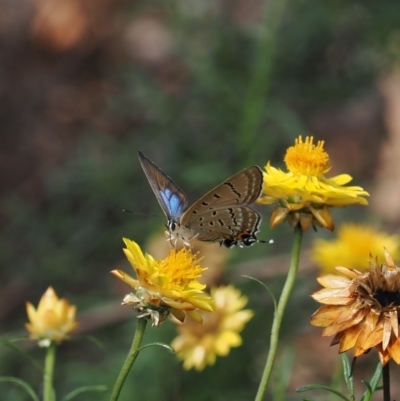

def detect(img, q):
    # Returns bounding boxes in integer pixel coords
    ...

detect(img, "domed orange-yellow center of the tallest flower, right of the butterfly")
[284,136,330,176]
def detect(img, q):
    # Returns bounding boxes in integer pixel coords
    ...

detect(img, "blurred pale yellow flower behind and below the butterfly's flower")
[171,285,253,370]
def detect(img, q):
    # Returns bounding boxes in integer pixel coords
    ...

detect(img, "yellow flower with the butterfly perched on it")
[111,238,215,326]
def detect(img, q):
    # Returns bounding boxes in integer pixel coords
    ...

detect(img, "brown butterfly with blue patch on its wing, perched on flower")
[139,152,264,248]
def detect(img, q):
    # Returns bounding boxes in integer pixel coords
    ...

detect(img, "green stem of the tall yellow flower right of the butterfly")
[255,226,303,401]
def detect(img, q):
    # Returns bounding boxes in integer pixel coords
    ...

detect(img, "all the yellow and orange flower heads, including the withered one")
[26,137,400,370]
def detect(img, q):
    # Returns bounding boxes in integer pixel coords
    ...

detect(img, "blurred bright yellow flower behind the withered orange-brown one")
[311,223,400,273]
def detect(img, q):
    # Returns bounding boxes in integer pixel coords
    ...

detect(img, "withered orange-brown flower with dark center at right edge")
[311,250,400,365]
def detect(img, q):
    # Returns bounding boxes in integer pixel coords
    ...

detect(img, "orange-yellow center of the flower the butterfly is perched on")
[160,248,205,286]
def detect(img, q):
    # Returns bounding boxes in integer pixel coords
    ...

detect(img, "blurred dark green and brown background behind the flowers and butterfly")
[0,0,400,401]
